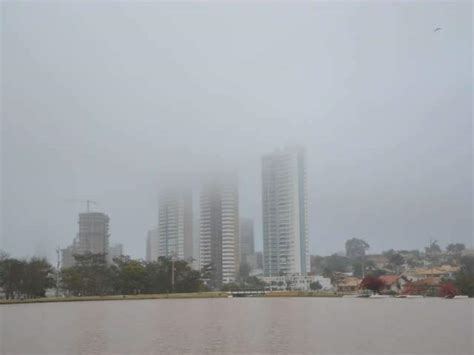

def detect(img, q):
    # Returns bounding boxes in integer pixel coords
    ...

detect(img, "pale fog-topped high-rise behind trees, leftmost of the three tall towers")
[158,189,193,260]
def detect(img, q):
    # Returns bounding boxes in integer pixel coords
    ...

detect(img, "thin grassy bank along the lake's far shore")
[0,291,340,304]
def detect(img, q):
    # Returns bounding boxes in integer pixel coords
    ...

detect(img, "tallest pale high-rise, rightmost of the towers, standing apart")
[262,148,310,276]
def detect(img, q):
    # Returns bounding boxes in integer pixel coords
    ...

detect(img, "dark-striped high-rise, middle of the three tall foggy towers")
[200,176,240,287]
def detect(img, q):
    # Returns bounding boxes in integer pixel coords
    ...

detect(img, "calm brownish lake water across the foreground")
[0,298,474,354]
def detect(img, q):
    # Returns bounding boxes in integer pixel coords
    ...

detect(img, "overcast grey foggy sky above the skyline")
[0,1,473,257]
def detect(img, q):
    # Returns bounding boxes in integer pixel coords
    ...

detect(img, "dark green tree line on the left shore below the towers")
[0,253,207,299]
